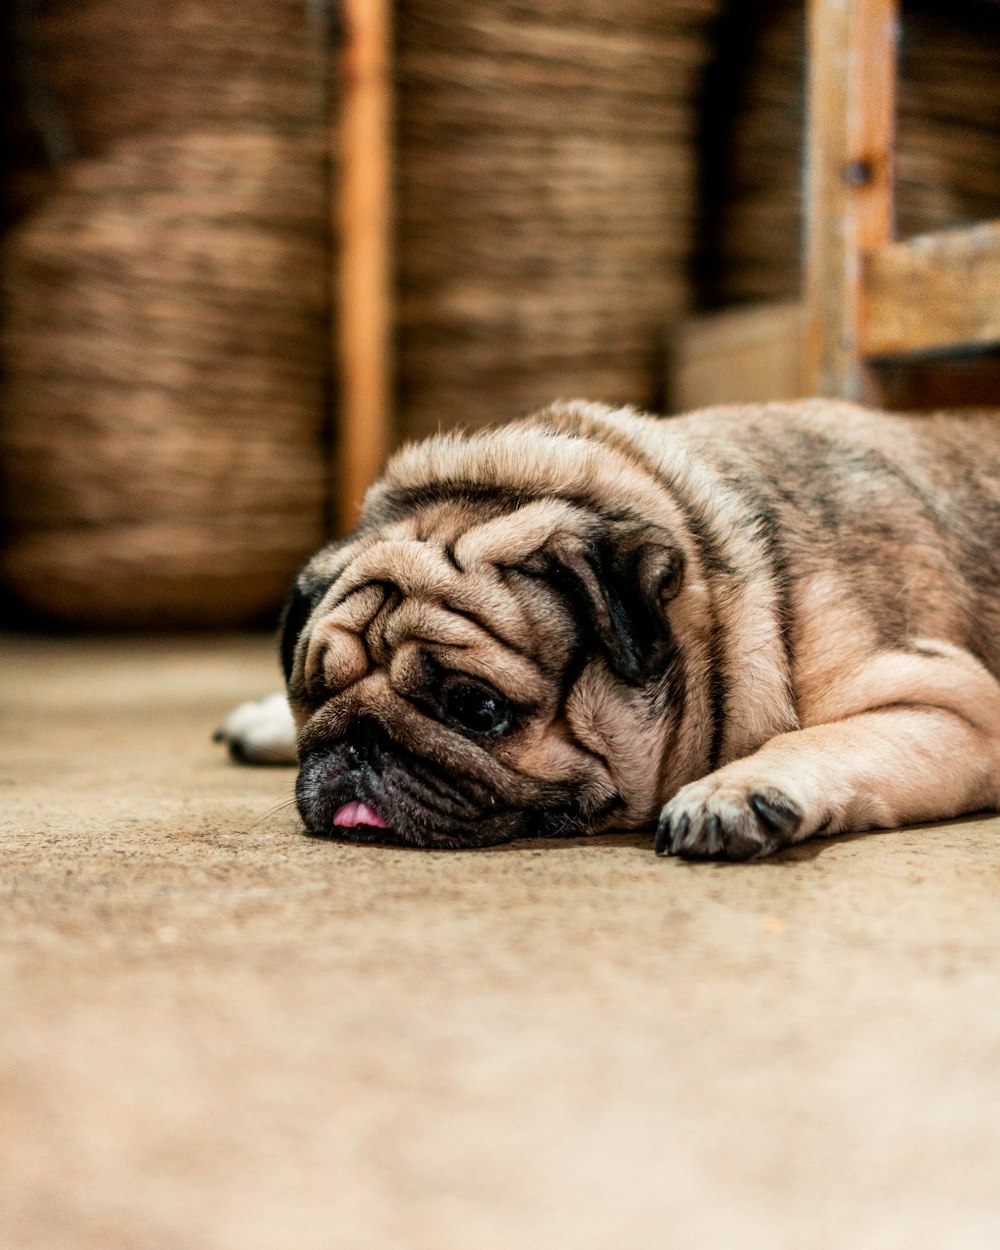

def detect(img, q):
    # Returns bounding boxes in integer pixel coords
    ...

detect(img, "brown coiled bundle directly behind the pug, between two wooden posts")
[396,0,718,436]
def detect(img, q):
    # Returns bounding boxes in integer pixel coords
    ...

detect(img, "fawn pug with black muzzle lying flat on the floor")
[216,400,1000,860]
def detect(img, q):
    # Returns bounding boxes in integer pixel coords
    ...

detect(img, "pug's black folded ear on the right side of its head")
[544,523,684,686]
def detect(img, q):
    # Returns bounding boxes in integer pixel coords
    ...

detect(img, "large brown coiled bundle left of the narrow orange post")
[3,0,328,626]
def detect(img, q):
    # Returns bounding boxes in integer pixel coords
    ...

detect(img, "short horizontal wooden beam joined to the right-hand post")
[861,221,1000,358]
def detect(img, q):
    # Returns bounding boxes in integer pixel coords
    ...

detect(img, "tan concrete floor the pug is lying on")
[0,639,1000,1250]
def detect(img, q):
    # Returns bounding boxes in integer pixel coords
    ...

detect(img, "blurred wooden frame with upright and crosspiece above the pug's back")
[670,0,1000,408]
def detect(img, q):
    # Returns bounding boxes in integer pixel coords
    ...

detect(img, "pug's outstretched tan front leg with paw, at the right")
[656,644,1000,860]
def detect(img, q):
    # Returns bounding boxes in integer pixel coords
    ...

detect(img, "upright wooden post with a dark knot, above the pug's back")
[803,0,899,401]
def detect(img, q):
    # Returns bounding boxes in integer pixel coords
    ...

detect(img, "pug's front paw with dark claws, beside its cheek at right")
[655,776,804,860]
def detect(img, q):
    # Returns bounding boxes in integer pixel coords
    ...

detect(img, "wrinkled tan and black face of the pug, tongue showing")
[283,501,679,846]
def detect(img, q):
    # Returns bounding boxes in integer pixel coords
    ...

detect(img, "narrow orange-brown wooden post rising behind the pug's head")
[333,0,393,533]
